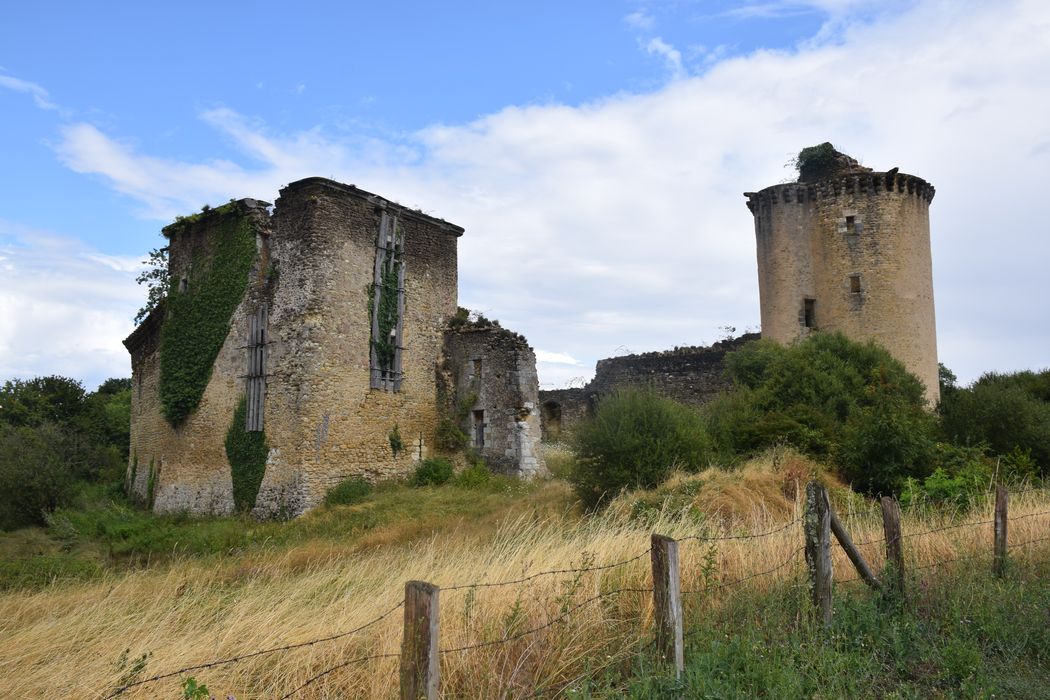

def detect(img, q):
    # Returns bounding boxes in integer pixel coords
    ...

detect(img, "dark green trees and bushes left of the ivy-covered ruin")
[0,376,131,530]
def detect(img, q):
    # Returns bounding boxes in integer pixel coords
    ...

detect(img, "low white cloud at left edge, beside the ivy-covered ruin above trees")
[0,220,142,389]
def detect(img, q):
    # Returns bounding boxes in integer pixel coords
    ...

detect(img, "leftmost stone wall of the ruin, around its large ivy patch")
[124,199,270,514]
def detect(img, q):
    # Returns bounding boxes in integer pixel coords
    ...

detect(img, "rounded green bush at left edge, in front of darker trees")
[0,423,76,530]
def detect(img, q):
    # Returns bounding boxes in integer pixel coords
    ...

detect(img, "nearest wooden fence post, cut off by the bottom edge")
[401,581,441,700]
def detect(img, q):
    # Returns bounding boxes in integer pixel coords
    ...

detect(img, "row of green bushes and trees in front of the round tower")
[572,334,1050,506]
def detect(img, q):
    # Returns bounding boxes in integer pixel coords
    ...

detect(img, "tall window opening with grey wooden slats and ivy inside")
[370,210,404,391]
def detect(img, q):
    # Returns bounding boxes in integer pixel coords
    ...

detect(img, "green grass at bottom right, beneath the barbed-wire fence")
[565,550,1050,700]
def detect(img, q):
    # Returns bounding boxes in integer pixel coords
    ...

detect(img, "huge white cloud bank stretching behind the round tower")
[45,0,1050,383]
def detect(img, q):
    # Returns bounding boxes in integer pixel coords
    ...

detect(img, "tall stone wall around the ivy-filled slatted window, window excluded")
[256,177,463,515]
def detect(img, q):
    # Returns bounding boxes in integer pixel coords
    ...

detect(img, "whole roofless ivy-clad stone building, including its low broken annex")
[125,177,544,516]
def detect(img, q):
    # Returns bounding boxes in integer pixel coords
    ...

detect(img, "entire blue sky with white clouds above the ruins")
[0,0,1050,389]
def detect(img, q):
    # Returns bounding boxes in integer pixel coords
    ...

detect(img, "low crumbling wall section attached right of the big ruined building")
[445,327,546,478]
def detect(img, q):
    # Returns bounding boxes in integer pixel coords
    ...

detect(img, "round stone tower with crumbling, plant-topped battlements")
[744,144,940,405]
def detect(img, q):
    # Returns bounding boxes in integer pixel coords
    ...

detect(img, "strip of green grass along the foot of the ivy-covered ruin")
[0,476,537,590]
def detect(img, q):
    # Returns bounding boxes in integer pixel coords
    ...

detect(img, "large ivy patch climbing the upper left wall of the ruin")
[161,205,255,427]
